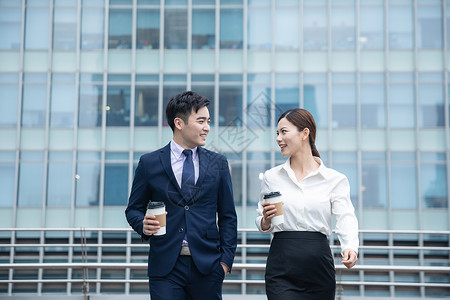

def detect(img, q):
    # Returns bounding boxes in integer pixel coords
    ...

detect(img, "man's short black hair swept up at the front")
[166,91,211,131]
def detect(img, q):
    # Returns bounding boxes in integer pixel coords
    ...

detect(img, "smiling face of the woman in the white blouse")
[277,118,308,157]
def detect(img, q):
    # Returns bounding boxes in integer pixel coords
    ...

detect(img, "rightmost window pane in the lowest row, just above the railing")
[420,164,448,208]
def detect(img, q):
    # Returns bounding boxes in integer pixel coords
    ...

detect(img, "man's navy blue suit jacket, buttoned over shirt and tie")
[125,143,237,276]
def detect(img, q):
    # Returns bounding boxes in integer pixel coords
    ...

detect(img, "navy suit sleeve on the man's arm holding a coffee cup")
[125,158,151,240]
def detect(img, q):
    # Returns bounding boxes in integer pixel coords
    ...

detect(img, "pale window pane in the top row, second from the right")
[389,6,413,49]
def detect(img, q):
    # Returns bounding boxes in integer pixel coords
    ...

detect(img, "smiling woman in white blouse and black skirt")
[256,108,359,300]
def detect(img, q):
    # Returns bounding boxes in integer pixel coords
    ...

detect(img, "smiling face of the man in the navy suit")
[180,106,210,149]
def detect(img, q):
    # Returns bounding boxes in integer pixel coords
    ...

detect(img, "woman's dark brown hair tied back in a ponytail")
[278,108,320,157]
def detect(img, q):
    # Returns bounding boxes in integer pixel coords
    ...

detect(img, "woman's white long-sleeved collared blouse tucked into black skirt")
[256,157,359,253]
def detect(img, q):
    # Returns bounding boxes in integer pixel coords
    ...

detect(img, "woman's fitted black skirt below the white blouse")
[266,231,336,300]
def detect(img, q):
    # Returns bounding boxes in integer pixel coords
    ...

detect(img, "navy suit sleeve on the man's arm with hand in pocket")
[217,158,237,271]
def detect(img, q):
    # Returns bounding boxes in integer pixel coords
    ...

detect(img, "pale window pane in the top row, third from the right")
[359,6,384,49]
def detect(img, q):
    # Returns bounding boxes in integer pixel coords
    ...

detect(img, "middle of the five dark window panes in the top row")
[164,9,187,49]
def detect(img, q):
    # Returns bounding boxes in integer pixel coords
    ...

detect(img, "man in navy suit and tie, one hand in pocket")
[125,91,237,300]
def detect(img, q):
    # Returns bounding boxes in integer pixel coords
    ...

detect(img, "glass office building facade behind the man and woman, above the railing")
[0,0,450,296]
